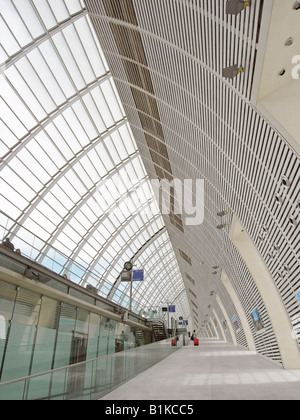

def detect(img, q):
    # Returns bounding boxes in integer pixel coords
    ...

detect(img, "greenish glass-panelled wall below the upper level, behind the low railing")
[0,280,152,382]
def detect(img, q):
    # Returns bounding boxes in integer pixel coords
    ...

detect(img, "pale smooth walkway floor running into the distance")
[102,339,300,401]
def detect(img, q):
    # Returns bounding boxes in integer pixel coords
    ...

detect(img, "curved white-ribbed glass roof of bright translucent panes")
[0,0,190,318]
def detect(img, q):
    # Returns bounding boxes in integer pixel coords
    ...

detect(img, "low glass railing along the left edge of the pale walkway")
[0,339,183,401]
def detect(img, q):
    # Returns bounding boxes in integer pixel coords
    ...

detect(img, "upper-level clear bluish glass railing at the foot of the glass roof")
[0,211,144,315]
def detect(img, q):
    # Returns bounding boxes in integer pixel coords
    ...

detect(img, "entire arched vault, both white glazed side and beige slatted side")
[0,0,300,363]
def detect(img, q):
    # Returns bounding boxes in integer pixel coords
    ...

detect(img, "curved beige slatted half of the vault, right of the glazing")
[86,0,300,361]
